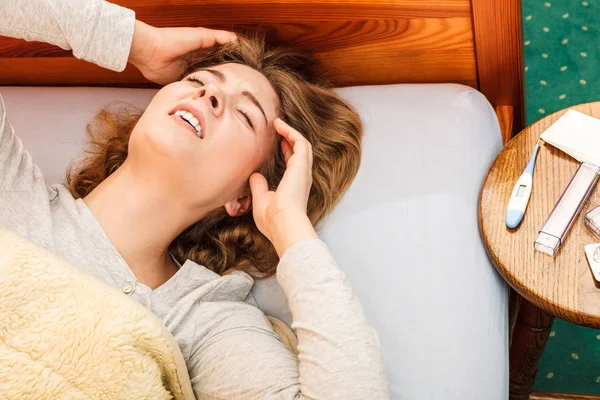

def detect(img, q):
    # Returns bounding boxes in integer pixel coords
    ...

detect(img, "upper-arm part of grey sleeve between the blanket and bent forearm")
[188,303,310,400]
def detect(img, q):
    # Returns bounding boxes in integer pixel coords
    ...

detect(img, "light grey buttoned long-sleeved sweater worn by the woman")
[0,0,391,399]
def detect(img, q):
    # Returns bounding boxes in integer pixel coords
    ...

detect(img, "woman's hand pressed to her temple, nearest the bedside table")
[250,118,318,257]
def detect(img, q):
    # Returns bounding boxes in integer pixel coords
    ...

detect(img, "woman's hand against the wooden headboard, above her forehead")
[128,20,237,85]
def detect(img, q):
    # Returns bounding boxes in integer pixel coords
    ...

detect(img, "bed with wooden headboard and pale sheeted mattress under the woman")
[0,0,524,399]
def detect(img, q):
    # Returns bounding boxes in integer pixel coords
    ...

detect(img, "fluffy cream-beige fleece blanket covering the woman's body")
[0,229,194,400]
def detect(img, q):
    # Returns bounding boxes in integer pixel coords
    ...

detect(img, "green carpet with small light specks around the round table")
[522,0,600,394]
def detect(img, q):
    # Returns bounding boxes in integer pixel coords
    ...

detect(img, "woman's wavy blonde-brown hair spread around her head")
[67,33,362,278]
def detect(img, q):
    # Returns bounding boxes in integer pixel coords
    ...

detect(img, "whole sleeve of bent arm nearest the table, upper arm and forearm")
[189,239,391,400]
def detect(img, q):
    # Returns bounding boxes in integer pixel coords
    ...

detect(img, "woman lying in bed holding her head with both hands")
[0,0,390,399]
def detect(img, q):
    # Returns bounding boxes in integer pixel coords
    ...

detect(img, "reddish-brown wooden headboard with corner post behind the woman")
[0,0,524,136]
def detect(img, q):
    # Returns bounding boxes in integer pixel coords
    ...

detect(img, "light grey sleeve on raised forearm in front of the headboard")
[0,0,135,72]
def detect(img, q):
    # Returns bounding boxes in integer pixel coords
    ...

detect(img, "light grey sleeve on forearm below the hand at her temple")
[277,239,391,400]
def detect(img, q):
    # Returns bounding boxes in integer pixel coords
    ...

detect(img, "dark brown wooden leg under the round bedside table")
[509,299,554,400]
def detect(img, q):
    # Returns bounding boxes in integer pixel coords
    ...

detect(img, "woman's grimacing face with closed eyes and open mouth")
[127,63,278,215]
